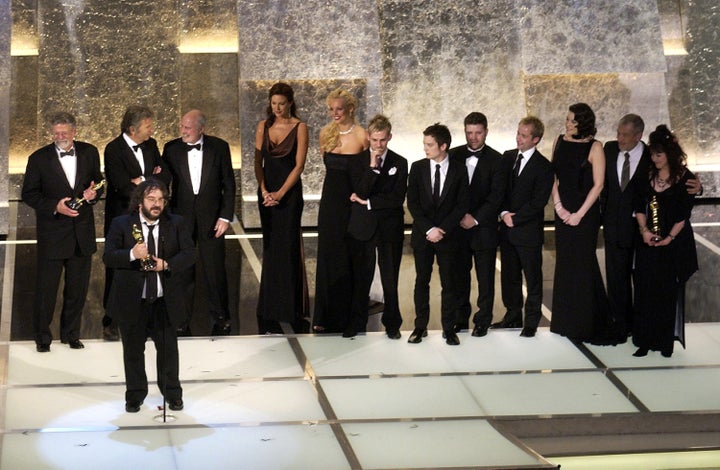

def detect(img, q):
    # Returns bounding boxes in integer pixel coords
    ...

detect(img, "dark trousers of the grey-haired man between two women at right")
[605,241,635,334]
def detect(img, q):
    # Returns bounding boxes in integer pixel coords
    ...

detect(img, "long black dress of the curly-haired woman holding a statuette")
[633,171,698,354]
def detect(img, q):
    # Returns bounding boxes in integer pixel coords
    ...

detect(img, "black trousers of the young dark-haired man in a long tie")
[413,241,458,331]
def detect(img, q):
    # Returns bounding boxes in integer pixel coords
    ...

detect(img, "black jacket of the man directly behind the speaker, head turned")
[105,134,171,234]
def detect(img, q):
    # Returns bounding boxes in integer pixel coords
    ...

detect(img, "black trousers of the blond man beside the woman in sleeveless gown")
[500,239,543,328]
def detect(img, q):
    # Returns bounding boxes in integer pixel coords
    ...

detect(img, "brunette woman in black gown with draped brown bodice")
[255,83,309,334]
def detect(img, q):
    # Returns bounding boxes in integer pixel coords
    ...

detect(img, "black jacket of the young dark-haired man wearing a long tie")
[407,158,468,249]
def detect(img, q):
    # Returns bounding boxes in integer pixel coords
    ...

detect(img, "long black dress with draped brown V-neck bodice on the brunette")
[257,122,308,334]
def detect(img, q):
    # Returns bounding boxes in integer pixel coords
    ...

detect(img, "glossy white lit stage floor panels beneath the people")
[0,323,720,469]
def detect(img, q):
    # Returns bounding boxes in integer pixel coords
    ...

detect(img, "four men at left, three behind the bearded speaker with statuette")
[22,106,235,412]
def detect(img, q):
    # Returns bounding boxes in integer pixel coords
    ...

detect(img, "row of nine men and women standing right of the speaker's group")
[255,83,702,356]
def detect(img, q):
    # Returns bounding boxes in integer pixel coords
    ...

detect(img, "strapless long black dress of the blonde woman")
[313,153,356,333]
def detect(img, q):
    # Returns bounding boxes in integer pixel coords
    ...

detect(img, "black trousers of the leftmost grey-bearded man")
[33,247,92,344]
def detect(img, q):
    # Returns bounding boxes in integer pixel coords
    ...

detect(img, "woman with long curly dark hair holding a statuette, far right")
[633,125,698,357]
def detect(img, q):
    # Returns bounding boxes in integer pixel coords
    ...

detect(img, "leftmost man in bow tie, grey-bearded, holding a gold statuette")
[22,112,102,352]
